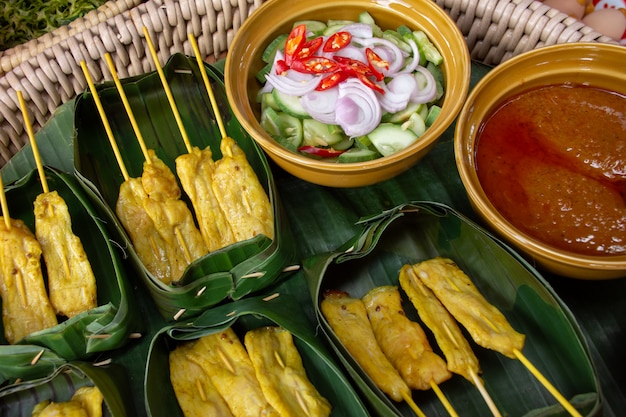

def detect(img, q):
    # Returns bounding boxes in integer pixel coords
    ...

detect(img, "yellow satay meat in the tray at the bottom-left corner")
[32,387,104,417]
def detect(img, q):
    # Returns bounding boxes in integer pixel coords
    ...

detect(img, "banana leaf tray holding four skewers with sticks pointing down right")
[303,202,602,417]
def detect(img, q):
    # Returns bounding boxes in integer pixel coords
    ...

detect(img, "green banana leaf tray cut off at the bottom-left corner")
[0,354,136,417]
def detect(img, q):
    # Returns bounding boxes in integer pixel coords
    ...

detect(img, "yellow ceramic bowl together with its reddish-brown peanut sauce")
[454,43,626,280]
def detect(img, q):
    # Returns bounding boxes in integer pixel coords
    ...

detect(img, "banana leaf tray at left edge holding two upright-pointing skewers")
[0,167,136,360]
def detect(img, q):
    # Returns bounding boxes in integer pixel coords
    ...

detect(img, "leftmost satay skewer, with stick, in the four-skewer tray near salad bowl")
[80,61,197,284]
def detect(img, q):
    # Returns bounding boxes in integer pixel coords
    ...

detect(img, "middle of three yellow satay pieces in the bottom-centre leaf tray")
[187,328,280,417]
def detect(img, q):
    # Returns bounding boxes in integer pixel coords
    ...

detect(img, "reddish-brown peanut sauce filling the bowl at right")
[476,84,626,255]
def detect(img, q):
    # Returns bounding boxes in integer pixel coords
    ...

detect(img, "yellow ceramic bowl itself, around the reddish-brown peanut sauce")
[454,43,626,279]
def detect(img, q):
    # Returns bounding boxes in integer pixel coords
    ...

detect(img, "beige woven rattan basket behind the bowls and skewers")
[0,0,614,166]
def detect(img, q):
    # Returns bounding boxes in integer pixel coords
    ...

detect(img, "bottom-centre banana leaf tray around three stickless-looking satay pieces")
[144,293,369,417]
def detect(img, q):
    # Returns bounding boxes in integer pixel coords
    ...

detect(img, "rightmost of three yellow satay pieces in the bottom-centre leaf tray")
[244,326,332,417]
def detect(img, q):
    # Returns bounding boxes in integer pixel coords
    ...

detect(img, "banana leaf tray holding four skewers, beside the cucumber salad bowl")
[74,54,295,320]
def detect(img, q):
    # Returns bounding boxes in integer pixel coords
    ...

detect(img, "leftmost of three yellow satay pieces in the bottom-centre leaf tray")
[169,342,232,417]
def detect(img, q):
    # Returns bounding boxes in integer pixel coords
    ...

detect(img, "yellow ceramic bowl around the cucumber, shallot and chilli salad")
[225,0,470,187]
